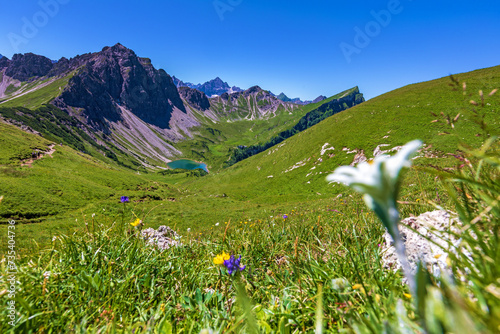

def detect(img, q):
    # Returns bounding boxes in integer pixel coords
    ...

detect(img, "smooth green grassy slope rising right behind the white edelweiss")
[190,66,500,202]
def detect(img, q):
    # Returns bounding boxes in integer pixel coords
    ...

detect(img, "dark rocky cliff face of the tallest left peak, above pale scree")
[54,44,185,131]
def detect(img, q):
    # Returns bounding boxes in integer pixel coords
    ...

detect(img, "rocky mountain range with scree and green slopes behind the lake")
[0,44,364,167]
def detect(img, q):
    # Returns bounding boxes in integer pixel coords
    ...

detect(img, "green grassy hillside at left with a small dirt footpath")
[0,123,186,250]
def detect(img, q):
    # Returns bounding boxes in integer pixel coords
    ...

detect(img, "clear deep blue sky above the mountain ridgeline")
[0,0,500,99]
